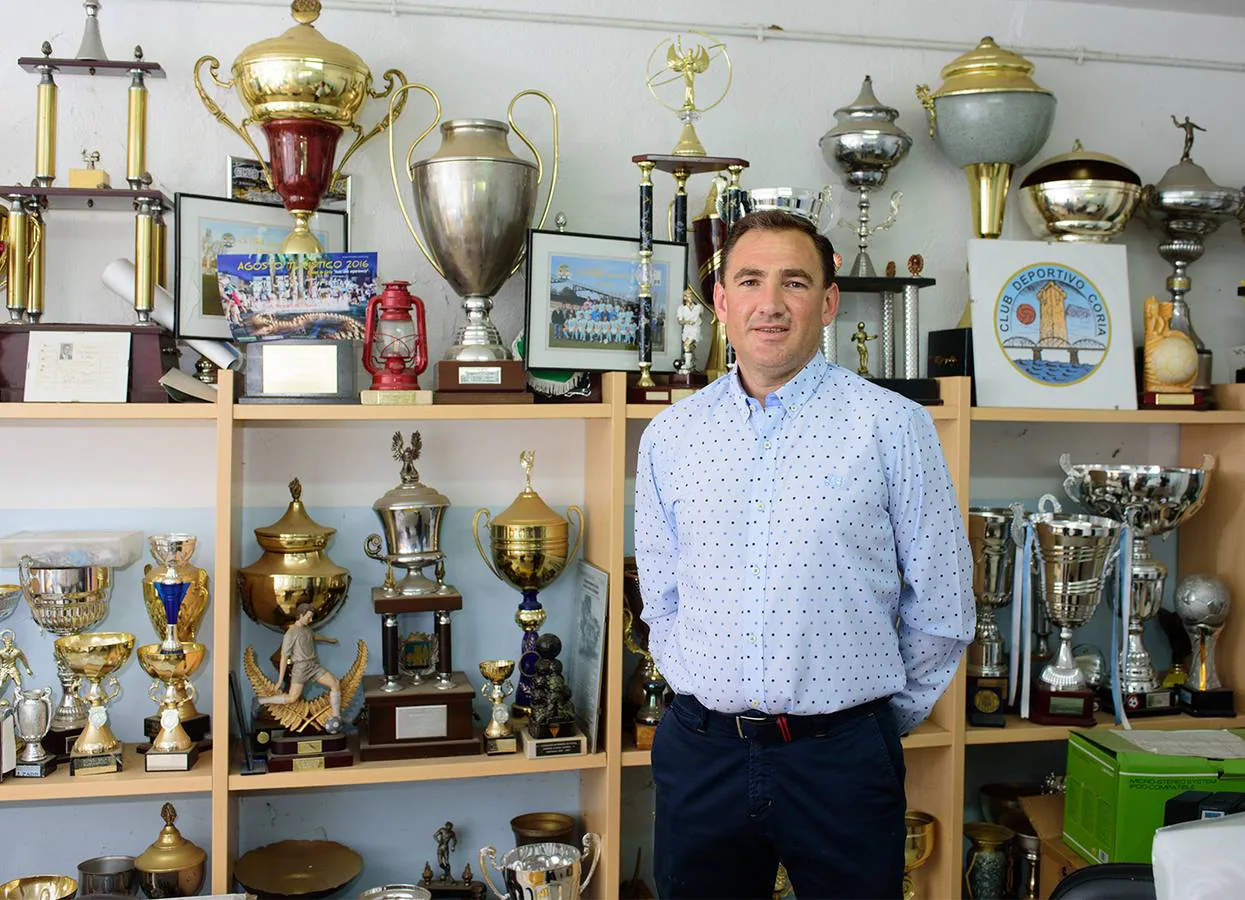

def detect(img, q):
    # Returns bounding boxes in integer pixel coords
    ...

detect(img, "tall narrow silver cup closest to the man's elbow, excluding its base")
[969,507,1016,678]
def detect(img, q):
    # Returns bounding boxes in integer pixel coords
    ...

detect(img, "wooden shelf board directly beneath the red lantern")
[234,403,610,422]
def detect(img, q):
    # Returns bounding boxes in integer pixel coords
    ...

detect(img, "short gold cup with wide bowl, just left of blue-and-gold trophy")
[54,631,134,776]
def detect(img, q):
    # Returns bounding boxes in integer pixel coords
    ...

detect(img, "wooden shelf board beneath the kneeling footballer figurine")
[229,753,605,793]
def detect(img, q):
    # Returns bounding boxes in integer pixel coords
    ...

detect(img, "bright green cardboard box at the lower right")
[1063,728,1245,863]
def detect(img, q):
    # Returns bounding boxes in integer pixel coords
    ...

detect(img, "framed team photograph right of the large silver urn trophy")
[524,229,687,372]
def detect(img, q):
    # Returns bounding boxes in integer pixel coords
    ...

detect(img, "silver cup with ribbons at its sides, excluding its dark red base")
[1028,513,1122,691]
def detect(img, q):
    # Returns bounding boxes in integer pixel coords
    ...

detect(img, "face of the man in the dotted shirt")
[713,230,839,383]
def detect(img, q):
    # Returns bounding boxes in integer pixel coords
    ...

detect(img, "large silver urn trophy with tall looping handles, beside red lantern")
[388,85,558,402]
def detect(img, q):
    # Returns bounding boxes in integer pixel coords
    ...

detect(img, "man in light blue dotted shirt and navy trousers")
[635,212,975,900]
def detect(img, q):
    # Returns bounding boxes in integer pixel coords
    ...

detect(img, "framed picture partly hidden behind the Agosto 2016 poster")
[173,194,350,341]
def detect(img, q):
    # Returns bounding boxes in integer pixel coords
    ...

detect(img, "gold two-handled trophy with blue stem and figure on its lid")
[472,451,584,716]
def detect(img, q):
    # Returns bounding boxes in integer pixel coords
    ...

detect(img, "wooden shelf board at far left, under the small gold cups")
[0,744,212,804]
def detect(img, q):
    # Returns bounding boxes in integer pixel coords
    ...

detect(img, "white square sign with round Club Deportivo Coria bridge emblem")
[969,240,1137,410]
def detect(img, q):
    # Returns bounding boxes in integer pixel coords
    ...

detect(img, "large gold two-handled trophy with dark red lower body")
[194,0,406,253]
